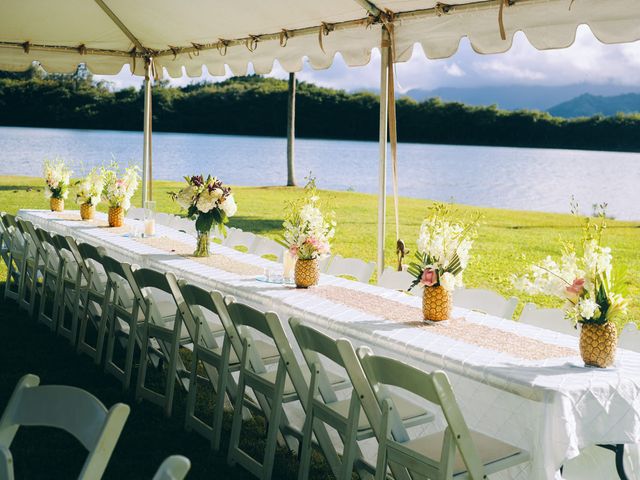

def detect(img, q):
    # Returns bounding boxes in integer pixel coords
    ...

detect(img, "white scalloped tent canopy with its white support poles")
[0,0,640,272]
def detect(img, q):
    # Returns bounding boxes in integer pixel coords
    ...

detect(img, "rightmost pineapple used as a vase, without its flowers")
[580,322,618,368]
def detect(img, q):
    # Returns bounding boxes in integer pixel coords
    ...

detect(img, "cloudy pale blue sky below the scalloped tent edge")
[95,25,640,92]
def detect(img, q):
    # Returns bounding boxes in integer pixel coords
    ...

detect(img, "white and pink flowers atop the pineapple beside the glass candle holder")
[280,177,336,260]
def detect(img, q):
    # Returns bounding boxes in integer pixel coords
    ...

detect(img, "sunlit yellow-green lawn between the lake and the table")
[0,177,640,321]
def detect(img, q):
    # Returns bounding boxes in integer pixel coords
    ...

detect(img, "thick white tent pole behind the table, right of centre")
[377,28,390,276]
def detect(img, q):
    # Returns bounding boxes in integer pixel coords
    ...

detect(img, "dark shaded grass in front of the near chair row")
[0,283,338,480]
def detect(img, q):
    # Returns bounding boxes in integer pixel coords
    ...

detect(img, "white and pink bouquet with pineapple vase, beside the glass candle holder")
[280,178,336,288]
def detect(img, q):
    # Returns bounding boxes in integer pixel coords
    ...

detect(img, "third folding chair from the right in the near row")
[227,304,348,480]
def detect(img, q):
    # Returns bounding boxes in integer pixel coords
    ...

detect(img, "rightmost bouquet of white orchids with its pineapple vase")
[513,205,628,368]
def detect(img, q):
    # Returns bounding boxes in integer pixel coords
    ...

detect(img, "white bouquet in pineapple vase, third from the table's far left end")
[101,162,140,227]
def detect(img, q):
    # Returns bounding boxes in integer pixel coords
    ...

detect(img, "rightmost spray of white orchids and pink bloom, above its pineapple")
[513,205,627,325]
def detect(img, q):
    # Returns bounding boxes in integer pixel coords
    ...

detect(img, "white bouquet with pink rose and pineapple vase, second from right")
[408,204,479,322]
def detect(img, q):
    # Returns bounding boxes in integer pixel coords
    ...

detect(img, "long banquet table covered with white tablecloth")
[19,210,640,480]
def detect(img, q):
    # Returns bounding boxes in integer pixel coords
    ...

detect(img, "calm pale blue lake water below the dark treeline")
[0,127,640,220]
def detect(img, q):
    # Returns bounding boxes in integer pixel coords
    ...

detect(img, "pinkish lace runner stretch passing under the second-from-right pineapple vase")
[309,285,578,360]
